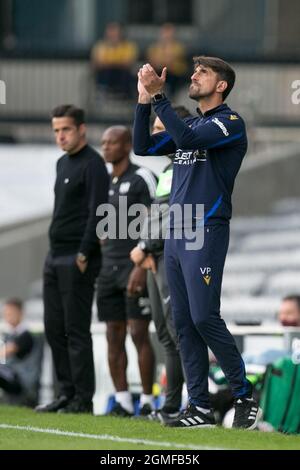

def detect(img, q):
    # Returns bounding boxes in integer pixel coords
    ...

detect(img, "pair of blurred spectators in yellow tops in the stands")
[91,23,188,97]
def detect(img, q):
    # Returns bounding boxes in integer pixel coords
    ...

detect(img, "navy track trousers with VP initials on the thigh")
[165,225,252,408]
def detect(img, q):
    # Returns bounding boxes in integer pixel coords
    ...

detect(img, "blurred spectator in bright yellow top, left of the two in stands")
[91,23,138,97]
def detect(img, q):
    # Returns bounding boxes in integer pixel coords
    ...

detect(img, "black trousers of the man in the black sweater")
[43,254,100,401]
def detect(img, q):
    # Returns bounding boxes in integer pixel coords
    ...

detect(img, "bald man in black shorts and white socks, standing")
[97,126,156,417]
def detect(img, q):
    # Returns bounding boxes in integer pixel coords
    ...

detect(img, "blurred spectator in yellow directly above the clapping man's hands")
[146,23,188,97]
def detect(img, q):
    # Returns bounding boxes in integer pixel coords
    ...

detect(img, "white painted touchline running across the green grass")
[0,424,225,450]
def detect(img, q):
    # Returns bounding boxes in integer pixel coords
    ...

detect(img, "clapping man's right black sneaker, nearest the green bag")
[232,398,262,431]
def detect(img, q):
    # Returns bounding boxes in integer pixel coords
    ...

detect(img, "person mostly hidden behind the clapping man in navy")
[130,106,190,423]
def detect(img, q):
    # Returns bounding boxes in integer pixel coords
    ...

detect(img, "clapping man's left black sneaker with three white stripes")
[165,405,216,429]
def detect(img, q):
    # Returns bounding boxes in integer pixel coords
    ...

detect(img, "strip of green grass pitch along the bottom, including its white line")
[0,406,300,451]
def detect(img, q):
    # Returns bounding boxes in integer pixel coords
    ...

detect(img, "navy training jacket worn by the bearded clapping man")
[133,98,247,227]
